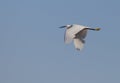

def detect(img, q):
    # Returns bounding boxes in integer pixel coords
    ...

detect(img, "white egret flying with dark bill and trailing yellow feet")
[59,24,100,50]
